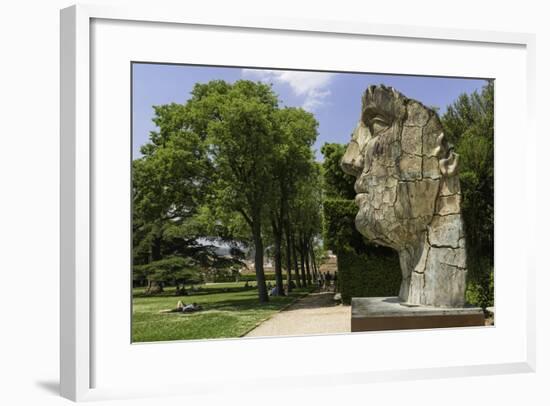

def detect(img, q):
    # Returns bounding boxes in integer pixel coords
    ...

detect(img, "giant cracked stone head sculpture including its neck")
[341,85,467,307]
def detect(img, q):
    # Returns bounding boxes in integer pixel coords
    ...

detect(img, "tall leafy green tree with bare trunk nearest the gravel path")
[185,80,278,302]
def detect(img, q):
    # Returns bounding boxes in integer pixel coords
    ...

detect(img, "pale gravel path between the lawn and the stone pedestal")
[246,292,351,337]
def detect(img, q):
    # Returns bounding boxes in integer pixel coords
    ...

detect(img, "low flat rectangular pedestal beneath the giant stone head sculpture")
[351,297,485,332]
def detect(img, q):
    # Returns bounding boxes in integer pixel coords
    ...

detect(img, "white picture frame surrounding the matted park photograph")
[60,5,536,401]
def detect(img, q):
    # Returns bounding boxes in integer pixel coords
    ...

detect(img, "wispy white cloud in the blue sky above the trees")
[242,69,335,111]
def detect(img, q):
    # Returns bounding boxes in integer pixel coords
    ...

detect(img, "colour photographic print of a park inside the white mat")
[131,62,495,343]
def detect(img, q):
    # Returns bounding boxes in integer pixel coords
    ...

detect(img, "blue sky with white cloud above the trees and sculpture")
[132,63,486,160]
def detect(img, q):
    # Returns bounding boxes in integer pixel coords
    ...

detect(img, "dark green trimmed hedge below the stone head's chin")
[323,199,401,304]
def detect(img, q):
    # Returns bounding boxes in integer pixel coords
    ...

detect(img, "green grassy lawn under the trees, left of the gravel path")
[132,282,314,342]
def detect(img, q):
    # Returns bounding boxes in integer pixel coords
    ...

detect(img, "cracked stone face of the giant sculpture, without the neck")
[341,86,441,250]
